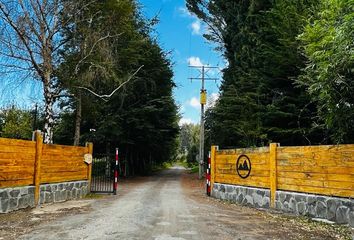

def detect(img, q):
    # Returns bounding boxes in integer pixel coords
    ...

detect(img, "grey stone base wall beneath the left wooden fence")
[0,181,88,213]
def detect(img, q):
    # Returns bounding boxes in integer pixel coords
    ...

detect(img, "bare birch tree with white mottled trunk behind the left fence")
[0,0,71,143]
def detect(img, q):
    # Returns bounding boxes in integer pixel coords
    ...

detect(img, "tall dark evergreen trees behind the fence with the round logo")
[187,0,346,147]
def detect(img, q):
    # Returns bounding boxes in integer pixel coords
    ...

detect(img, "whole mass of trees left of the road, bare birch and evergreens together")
[0,0,179,174]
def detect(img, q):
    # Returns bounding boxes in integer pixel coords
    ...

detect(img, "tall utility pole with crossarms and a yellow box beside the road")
[189,66,219,179]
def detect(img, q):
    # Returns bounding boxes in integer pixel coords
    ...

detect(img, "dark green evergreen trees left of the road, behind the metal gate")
[56,0,179,174]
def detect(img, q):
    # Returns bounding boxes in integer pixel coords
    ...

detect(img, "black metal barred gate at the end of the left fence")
[91,154,115,193]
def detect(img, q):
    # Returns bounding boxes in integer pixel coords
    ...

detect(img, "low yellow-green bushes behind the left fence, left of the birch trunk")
[0,106,33,140]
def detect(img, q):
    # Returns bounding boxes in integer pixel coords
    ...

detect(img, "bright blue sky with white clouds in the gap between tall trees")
[140,0,224,123]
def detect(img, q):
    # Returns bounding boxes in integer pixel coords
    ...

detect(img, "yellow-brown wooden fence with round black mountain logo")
[211,143,354,206]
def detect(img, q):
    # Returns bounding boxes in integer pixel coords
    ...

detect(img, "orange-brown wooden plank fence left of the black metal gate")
[0,133,93,203]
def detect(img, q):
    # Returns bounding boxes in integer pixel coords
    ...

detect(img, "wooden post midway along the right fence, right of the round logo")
[269,143,278,208]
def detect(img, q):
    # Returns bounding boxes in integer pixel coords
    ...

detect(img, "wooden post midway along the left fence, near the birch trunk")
[34,131,43,206]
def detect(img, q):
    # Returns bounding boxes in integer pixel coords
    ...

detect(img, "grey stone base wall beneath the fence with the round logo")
[211,183,354,227]
